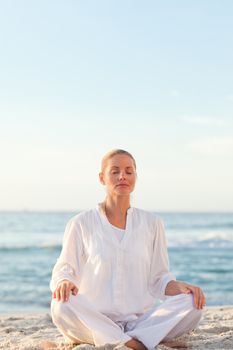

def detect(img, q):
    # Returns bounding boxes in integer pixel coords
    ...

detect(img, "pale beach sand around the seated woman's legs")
[0,306,233,350]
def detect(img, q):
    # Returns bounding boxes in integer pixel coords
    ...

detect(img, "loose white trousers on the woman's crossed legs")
[51,294,202,350]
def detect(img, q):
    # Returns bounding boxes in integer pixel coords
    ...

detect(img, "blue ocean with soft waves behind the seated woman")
[0,211,233,314]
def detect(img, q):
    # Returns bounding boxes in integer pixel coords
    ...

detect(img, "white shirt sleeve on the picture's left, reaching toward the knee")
[50,219,85,292]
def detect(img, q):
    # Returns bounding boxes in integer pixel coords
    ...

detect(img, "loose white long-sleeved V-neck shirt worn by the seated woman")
[50,204,175,320]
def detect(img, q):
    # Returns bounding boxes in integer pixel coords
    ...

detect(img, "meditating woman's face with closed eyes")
[99,154,137,196]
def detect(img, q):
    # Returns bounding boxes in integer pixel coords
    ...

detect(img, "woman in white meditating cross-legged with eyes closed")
[50,149,205,350]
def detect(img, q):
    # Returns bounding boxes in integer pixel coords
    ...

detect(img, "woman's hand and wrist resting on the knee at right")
[165,281,206,309]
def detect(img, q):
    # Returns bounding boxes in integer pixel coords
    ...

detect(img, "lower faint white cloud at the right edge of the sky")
[188,137,233,156]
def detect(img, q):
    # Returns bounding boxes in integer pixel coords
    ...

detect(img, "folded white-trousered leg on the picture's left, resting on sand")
[51,294,131,346]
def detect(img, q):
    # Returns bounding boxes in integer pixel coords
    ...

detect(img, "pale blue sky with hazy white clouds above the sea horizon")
[0,0,233,212]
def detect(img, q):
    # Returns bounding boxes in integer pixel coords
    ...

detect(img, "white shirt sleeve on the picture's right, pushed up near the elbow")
[149,218,176,300]
